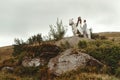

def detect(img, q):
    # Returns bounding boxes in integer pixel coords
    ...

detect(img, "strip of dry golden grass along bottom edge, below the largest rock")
[54,73,120,80]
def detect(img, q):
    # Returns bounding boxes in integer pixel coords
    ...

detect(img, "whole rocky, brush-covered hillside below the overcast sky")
[0,32,120,80]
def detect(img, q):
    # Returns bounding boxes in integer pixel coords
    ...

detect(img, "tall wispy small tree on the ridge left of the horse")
[49,18,67,40]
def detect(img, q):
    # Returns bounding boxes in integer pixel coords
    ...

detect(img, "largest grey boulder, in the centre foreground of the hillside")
[48,49,102,76]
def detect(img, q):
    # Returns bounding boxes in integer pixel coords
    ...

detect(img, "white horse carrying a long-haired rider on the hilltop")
[69,19,92,39]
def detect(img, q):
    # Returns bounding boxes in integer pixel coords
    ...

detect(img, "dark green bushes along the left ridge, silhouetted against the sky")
[12,34,43,56]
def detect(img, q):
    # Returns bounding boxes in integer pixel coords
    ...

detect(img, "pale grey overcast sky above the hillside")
[0,0,120,46]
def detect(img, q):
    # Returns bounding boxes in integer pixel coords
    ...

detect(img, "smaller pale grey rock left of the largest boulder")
[22,58,44,67]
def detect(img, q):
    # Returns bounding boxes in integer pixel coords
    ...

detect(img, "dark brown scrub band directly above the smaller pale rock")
[13,39,61,61]
